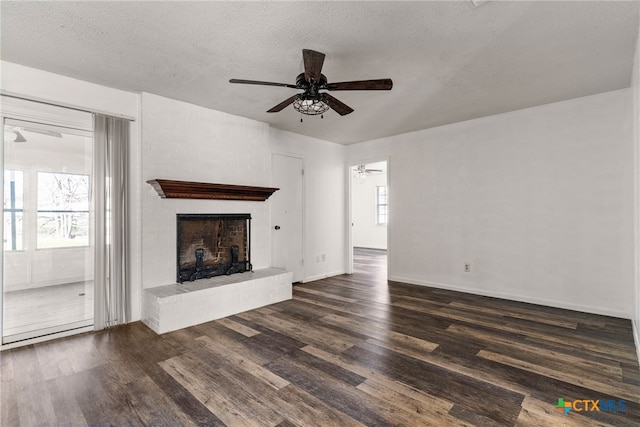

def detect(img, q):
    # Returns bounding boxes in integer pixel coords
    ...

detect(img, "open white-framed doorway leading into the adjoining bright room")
[347,159,389,273]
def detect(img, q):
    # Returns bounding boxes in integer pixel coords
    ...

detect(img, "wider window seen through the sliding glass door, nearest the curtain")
[37,172,89,249]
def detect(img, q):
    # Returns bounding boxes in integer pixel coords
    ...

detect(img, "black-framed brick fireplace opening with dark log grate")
[177,214,252,283]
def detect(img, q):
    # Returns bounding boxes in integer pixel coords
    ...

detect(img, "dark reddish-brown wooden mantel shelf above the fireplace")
[147,179,279,202]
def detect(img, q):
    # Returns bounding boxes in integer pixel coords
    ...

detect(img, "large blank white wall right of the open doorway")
[347,89,634,318]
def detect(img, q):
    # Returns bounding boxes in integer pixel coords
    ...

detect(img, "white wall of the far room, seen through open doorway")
[351,173,387,249]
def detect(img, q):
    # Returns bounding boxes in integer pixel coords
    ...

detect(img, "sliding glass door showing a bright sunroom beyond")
[2,118,94,344]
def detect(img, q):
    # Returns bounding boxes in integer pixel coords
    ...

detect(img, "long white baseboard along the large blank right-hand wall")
[389,276,630,319]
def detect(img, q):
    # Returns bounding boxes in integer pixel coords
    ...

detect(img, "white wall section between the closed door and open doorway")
[269,128,346,282]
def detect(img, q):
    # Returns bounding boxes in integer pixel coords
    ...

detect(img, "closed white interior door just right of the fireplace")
[269,154,304,282]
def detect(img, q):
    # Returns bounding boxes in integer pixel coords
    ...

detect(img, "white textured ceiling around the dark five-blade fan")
[0,1,639,144]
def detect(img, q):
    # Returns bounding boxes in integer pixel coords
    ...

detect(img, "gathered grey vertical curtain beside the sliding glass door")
[93,114,131,330]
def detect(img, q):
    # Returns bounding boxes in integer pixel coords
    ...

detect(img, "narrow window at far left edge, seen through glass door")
[4,169,24,251]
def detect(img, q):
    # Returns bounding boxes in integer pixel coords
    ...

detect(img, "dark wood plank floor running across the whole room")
[0,250,640,427]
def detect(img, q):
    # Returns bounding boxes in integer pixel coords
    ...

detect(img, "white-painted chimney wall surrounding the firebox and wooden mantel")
[141,93,271,288]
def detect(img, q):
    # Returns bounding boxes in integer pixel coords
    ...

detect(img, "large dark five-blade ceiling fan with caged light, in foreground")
[229,49,393,121]
